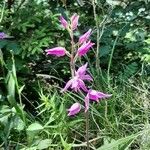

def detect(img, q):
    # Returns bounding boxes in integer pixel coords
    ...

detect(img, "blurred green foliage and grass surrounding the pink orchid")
[0,0,150,150]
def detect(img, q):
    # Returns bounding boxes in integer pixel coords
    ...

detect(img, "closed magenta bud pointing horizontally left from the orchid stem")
[45,47,66,57]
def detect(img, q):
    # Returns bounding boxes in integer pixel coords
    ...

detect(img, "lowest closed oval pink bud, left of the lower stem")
[68,103,81,116]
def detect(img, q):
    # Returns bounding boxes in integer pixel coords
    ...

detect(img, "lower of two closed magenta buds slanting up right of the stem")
[77,41,95,56]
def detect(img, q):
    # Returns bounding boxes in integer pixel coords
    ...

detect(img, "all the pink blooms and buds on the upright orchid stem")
[46,14,111,116]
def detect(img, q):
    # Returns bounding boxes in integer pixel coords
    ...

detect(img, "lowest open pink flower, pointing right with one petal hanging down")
[84,90,112,112]
